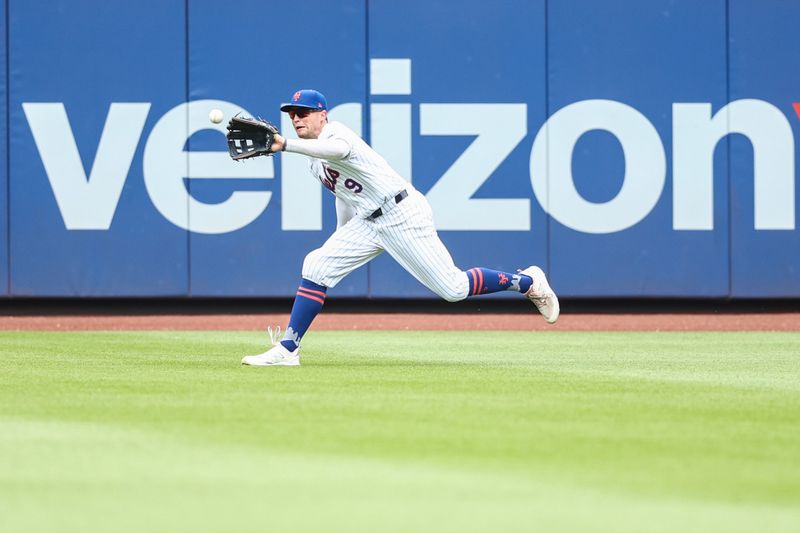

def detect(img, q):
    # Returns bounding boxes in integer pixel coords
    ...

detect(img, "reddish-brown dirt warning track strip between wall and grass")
[0,311,800,331]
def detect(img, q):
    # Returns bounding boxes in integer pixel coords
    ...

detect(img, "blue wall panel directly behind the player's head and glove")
[184,0,368,296]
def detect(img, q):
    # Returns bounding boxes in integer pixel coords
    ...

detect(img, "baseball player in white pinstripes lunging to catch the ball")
[233,89,559,366]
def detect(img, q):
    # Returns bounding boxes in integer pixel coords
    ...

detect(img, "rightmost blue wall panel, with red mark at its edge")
[728,0,800,297]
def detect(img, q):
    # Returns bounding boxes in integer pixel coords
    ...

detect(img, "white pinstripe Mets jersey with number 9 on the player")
[309,122,413,217]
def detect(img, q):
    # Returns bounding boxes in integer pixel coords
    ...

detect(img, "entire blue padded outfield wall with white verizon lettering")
[0,0,800,298]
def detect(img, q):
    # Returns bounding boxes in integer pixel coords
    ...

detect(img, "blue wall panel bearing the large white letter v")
[8,0,189,296]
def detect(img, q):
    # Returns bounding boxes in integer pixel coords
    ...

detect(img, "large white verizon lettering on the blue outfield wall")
[22,99,795,234]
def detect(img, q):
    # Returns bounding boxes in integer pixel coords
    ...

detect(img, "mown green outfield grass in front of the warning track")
[0,331,800,533]
